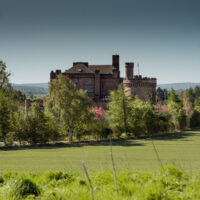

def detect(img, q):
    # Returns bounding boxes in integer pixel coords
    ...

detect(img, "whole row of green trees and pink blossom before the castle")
[0,63,200,144]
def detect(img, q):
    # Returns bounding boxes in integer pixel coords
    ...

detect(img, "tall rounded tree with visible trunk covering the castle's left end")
[48,75,91,141]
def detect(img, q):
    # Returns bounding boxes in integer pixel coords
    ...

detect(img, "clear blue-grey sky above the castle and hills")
[0,0,200,83]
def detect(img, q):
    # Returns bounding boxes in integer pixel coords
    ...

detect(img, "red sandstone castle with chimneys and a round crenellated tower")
[50,55,157,105]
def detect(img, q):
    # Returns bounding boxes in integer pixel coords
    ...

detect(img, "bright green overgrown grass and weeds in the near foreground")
[0,166,200,200]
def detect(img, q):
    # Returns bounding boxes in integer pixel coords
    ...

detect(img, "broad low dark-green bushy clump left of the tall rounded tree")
[12,104,61,144]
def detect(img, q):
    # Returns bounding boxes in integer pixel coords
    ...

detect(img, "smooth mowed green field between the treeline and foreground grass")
[0,130,200,172]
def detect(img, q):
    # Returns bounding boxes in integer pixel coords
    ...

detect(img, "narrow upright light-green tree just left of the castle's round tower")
[107,85,131,136]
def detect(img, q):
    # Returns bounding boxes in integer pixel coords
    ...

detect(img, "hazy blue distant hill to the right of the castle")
[157,83,200,90]
